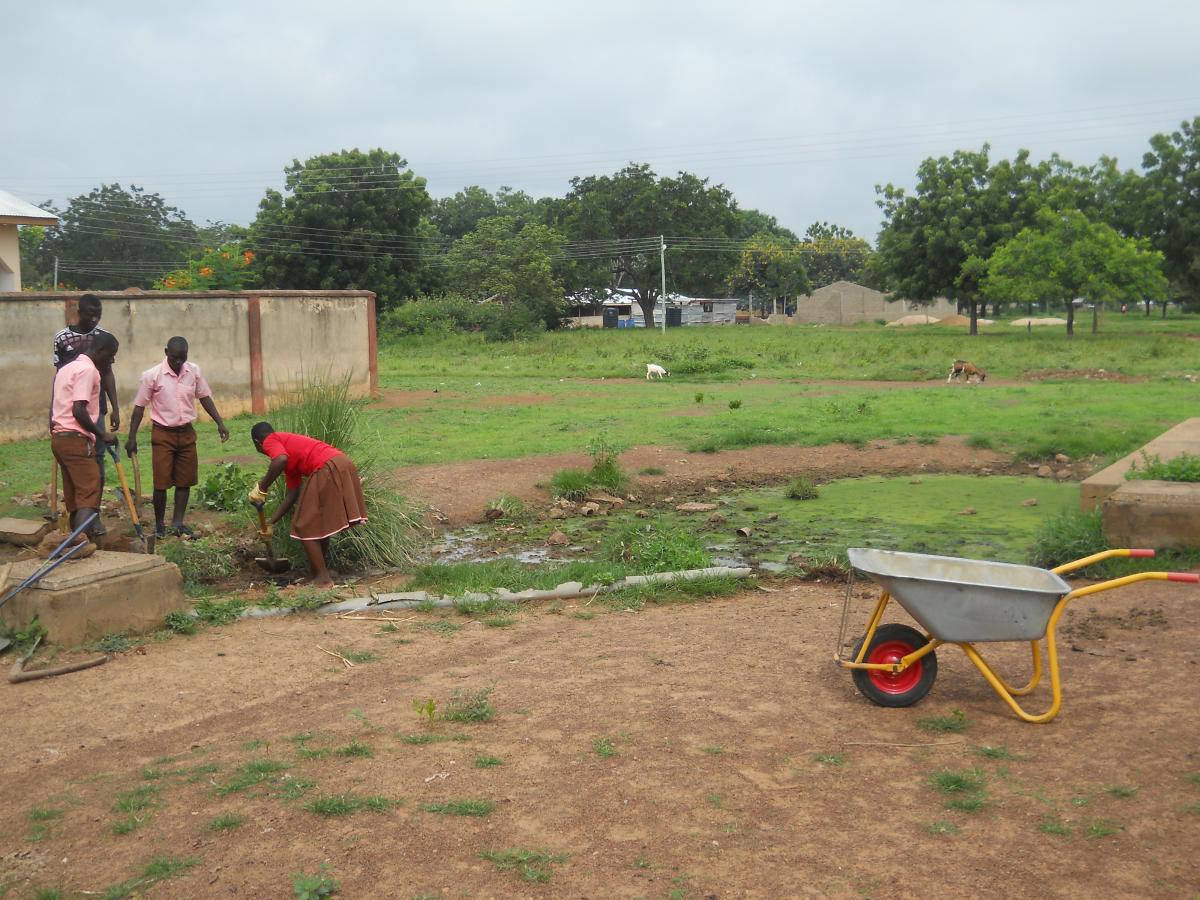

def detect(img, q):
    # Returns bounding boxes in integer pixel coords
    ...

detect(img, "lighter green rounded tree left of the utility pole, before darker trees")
[446,216,565,328]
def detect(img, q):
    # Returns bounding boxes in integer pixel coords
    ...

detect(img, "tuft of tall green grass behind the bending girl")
[271,376,427,569]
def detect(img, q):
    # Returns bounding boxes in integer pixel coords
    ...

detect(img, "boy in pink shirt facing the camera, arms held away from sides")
[125,336,229,538]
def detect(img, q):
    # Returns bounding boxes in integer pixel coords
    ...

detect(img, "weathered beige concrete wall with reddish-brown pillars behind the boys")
[0,290,377,440]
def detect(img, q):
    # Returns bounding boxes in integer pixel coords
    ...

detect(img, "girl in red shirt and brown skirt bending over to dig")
[250,422,367,588]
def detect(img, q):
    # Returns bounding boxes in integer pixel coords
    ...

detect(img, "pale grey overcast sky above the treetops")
[0,0,1200,240]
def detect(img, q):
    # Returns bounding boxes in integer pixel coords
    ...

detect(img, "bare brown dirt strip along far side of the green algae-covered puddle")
[396,438,1025,526]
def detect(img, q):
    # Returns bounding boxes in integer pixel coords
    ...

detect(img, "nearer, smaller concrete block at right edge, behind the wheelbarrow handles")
[1102,481,1200,550]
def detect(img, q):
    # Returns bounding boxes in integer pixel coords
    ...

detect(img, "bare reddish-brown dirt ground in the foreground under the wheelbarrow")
[0,582,1200,898]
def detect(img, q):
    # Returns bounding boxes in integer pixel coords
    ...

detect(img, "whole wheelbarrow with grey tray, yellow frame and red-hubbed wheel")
[834,547,1200,724]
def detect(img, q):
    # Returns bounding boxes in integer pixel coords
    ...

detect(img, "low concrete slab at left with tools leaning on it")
[0,550,188,647]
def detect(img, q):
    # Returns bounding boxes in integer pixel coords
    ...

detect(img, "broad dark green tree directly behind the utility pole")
[554,164,737,328]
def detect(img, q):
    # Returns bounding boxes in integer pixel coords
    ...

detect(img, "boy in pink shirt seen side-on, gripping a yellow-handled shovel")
[50,331,119,536]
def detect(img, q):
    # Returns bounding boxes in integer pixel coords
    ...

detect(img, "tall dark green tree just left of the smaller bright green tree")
[875,144,1073,335]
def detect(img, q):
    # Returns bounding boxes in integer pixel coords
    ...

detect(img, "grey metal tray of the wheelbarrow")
[847,547,1070,643]
